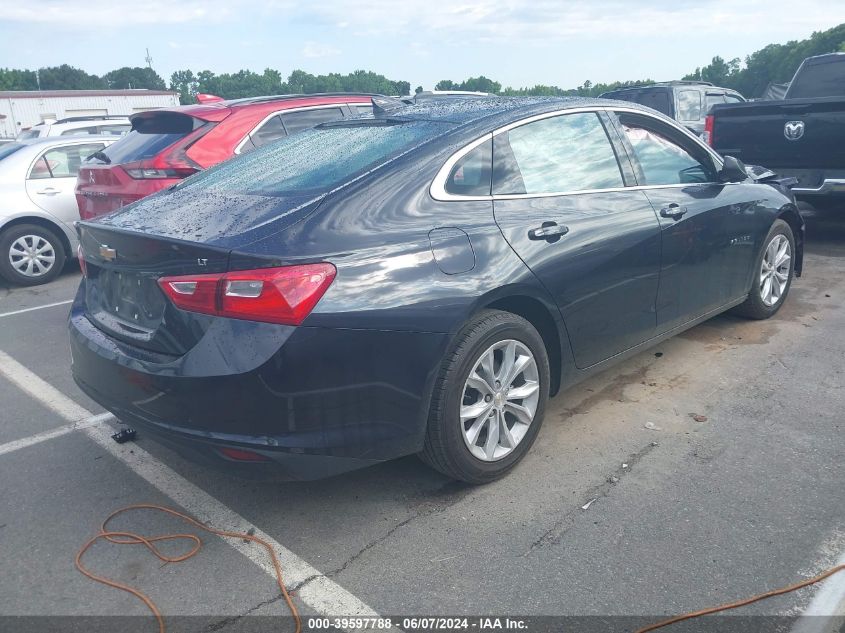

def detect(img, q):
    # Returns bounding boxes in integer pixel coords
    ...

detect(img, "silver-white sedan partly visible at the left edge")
[0,136,119,286]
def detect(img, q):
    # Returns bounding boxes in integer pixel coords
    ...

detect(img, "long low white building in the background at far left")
[0,90,179,138]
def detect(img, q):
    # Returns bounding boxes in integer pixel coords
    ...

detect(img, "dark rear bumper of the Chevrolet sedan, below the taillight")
[69,292,446,480]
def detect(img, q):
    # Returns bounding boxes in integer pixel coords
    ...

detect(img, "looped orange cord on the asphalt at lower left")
[76,504,302,633]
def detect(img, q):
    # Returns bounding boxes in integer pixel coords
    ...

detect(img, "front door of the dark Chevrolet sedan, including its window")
[617,112,757,332]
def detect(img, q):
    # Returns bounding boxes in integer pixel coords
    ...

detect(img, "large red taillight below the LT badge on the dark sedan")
[158,263,337,325]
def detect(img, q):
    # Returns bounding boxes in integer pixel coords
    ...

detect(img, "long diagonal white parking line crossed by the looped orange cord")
[0,352,377,617]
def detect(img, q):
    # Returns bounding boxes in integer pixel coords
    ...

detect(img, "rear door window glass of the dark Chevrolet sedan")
[493,112,623,194]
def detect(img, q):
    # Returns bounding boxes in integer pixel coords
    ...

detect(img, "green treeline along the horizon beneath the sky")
[0,24,845,103]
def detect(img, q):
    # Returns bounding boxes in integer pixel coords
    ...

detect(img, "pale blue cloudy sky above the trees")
[0,0,845,88]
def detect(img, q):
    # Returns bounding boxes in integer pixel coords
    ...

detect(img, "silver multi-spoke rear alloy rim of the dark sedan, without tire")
[460,339,540,462]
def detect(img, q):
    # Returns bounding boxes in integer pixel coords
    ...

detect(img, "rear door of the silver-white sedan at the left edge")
[26,141,106,224]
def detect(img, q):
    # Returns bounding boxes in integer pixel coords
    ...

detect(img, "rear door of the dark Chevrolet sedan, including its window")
[493,112,660,367]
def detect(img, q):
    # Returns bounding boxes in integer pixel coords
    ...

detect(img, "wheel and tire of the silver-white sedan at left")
[0,224,67,286]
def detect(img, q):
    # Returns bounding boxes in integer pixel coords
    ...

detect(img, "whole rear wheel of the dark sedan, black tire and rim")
[420,310,550,484]
